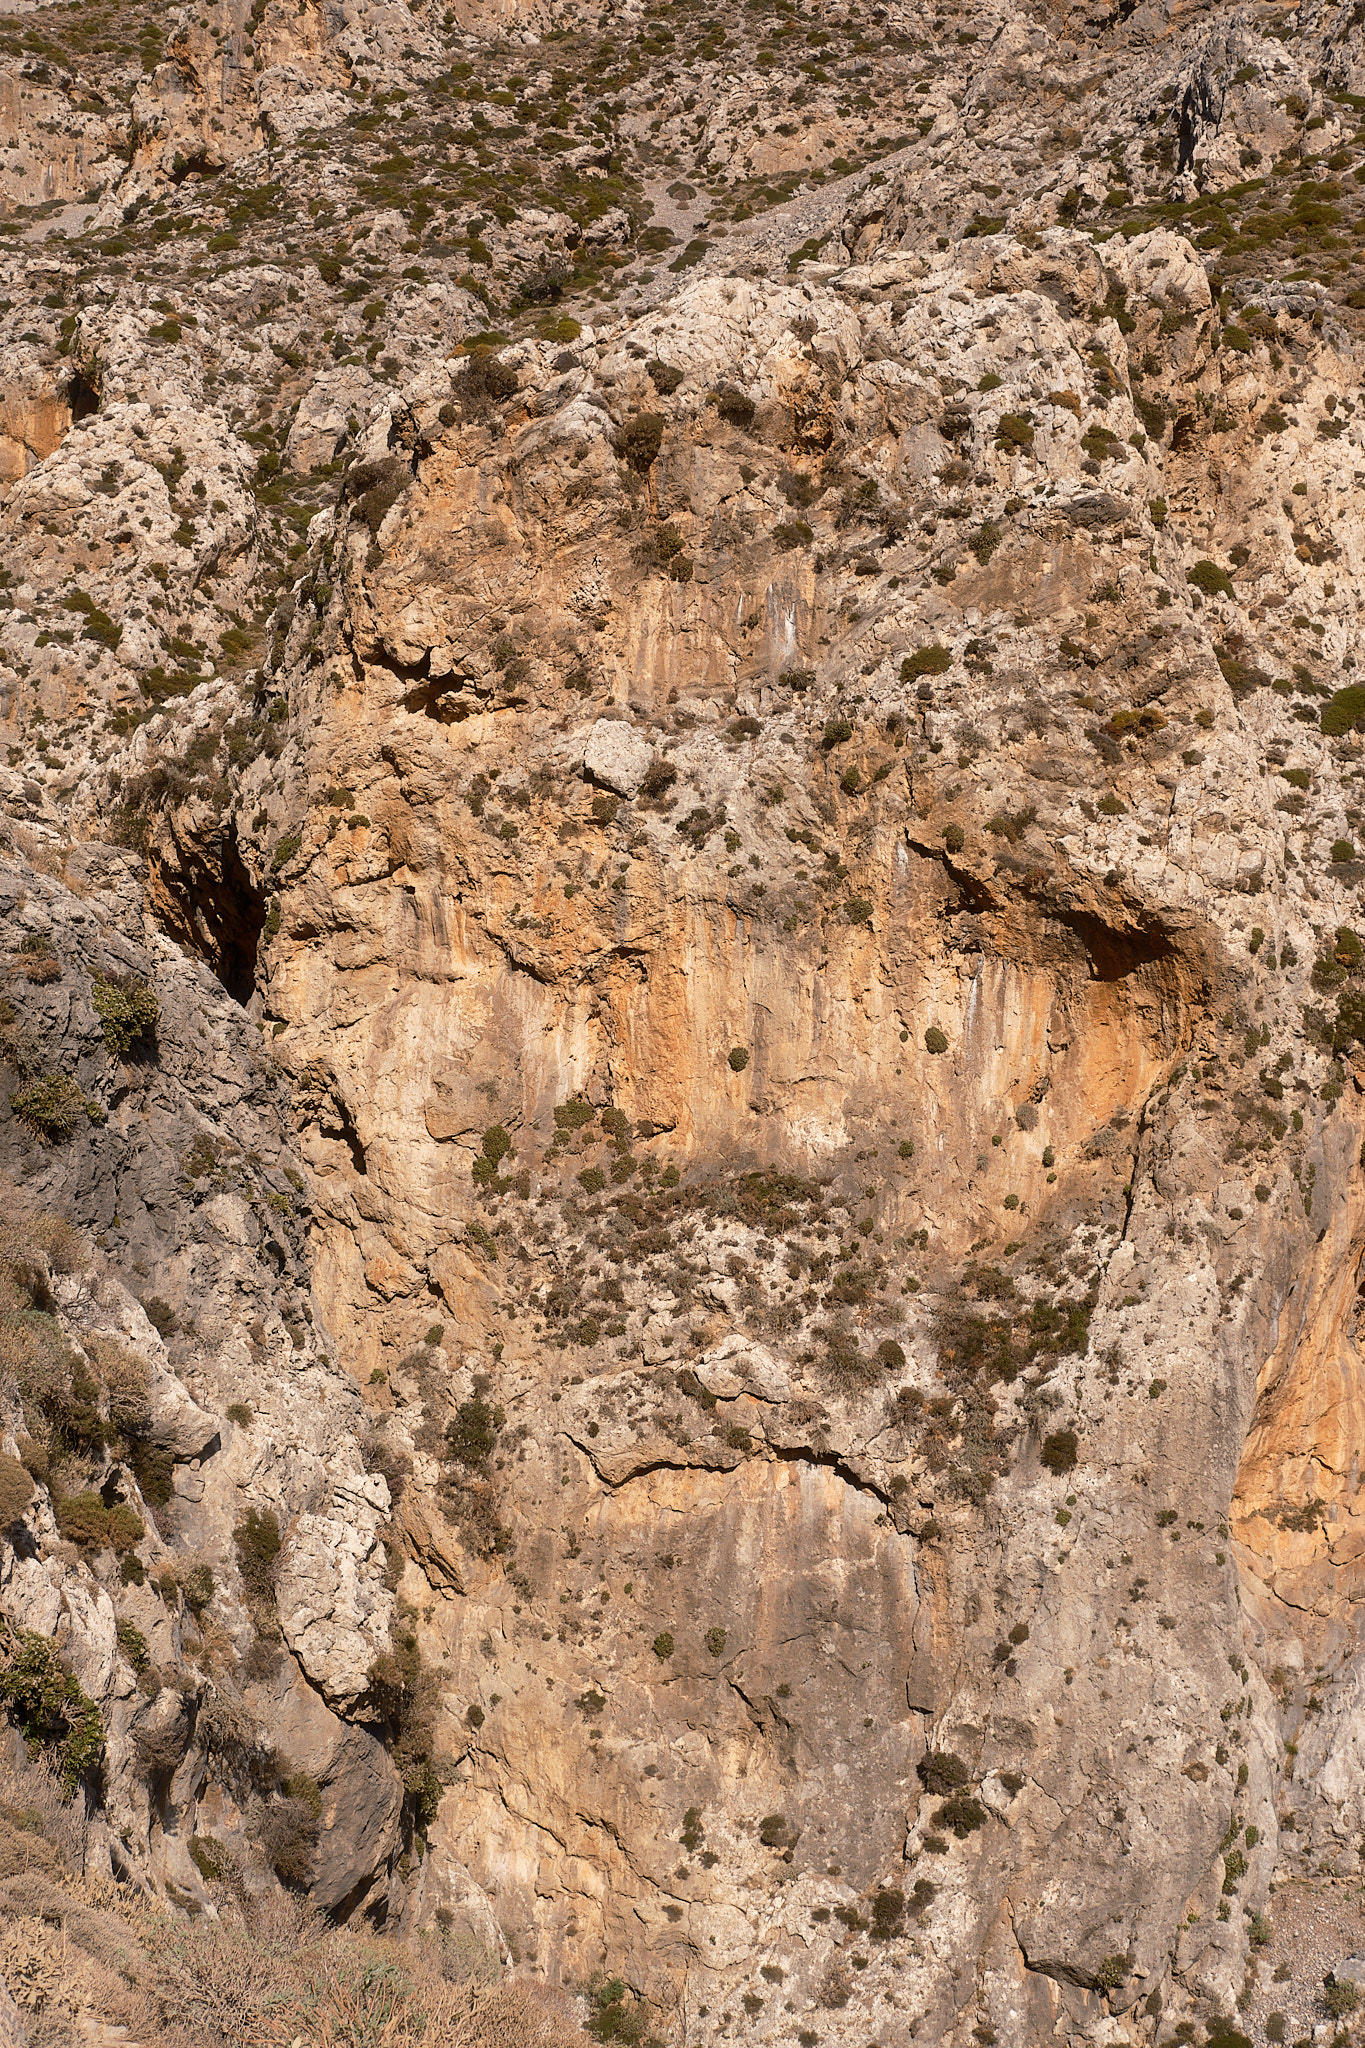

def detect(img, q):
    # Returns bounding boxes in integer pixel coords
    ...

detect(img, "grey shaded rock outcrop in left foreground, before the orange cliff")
[0,842,403,1911]
